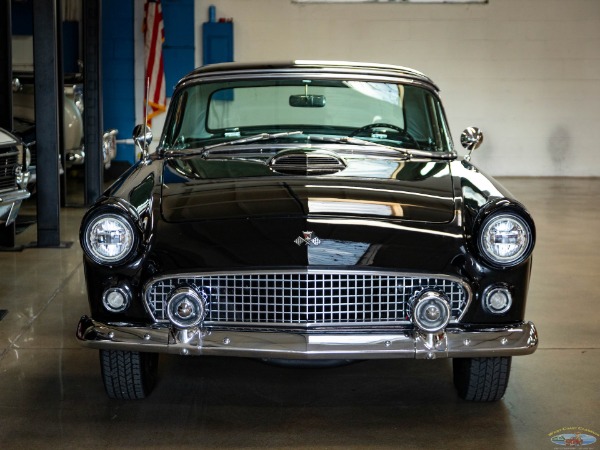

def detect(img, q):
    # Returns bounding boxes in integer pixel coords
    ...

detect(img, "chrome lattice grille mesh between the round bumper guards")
[145,271,469,326]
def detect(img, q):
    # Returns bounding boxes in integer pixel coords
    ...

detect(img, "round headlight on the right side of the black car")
[479,214,533,266]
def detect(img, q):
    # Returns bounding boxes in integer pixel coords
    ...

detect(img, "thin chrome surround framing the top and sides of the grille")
[142,268,473,328]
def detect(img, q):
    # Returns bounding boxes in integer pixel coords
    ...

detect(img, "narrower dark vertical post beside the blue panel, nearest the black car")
[82,0,104,205]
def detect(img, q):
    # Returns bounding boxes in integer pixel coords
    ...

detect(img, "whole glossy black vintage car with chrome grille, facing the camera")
[77,61,538,401]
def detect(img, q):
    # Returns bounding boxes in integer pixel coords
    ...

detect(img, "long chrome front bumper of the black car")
[77,316,538,359]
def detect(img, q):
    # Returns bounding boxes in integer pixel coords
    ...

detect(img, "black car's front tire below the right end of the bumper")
[452,356,512,402]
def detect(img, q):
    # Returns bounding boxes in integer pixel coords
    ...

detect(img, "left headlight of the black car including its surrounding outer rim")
[81,208,140,266]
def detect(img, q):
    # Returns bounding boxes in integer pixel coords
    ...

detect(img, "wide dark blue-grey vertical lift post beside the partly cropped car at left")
[32,0,63,247]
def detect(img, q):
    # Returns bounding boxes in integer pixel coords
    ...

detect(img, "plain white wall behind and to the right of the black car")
[195,0,600,176]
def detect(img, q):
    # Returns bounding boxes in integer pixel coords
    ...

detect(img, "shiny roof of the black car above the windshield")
[179,60,439,91]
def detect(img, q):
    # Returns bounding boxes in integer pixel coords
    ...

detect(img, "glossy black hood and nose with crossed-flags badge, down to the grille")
[154,158,462,273]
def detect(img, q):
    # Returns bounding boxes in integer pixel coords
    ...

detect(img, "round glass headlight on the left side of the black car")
[83,213,136,264]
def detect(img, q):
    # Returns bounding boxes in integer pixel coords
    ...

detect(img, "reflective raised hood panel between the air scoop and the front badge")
[162,162,455,223]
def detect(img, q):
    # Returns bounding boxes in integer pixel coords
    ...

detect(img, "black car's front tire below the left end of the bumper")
[100,350,158,400]
